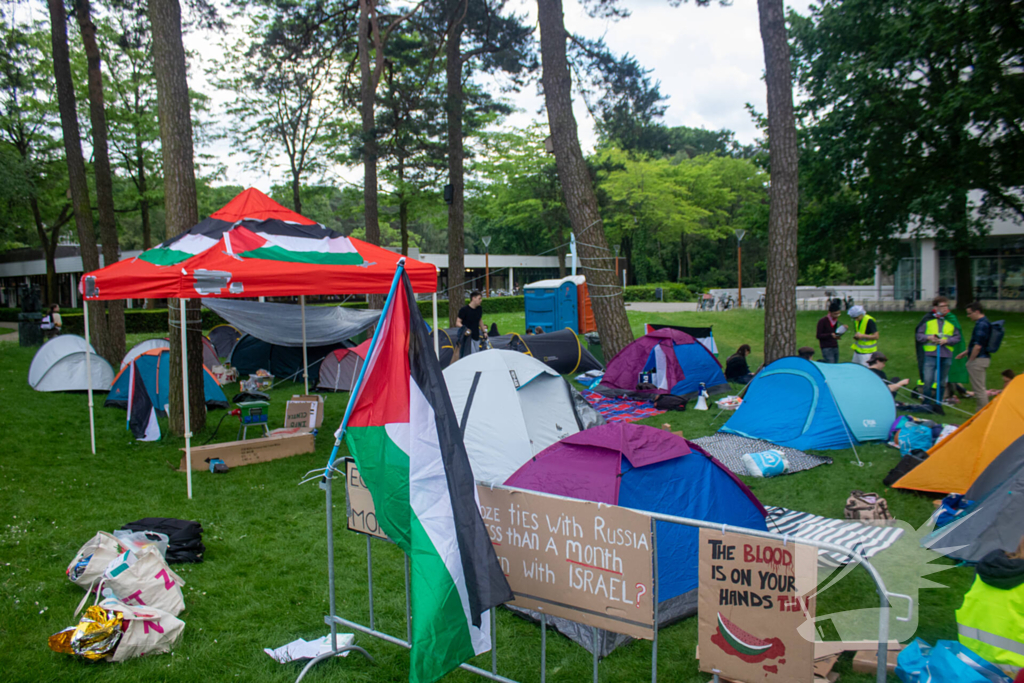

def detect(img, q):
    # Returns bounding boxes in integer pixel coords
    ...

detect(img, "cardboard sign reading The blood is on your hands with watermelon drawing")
[697,528,817,683]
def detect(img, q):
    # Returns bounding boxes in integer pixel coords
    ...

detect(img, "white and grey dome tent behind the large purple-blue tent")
[444,349,604,483]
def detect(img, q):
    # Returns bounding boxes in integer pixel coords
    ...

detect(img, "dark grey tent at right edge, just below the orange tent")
[922,436,1024,562]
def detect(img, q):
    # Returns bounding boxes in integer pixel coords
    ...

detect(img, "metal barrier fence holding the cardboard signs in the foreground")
[296,467,913,683]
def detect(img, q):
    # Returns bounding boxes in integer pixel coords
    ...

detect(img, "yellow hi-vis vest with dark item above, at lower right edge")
[956,539,1024,675]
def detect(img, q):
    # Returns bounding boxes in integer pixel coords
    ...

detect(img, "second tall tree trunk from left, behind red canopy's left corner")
[76,0,125,366]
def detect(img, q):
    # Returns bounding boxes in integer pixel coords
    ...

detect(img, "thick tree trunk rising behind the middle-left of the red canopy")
[149,0,206,435]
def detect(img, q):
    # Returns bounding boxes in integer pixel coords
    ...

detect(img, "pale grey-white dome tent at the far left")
[29,335,114,391]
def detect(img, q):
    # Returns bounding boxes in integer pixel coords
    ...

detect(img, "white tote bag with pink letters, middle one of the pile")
[103,548,185,616]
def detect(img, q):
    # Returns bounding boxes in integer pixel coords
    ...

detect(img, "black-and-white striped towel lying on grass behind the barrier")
[765,506,903,567]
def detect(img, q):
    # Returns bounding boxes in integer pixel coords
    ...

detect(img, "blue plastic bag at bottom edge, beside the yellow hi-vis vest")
[896,638,1012,683]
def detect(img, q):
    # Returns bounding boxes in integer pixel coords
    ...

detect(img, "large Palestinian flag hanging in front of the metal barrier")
[345,270,512,683]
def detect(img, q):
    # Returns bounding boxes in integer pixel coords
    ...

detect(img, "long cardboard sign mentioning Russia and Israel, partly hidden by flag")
[345,461,654,640]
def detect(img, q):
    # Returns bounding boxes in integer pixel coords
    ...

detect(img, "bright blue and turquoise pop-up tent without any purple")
[721,357,896,451]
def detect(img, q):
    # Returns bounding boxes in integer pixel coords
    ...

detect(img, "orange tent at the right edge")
[893,377,1024,494]
